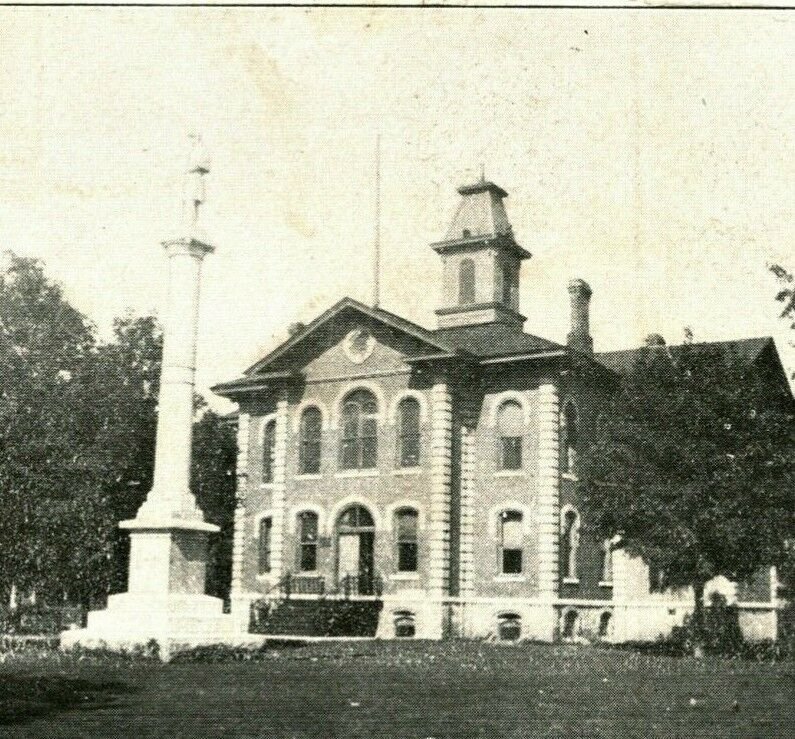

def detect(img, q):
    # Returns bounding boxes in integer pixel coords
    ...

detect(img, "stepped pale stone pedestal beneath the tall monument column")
[61,518,235,660]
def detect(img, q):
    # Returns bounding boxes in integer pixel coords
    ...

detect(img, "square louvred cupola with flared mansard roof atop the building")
[431,179,530,328]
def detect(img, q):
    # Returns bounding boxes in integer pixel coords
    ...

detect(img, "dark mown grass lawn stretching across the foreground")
[0,642,795,739]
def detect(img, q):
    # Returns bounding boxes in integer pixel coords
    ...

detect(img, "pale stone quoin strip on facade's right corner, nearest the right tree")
[538,383,560,641]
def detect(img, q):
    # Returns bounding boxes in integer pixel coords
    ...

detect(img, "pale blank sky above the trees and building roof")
[0,7,795,408]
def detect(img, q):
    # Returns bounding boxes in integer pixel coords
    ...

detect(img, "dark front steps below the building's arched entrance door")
[250,599,383,637]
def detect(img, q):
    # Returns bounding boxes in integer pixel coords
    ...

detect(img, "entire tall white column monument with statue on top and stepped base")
[61,137,233,659]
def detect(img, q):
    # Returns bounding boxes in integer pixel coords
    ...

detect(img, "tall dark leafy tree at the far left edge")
[0,254,95,598]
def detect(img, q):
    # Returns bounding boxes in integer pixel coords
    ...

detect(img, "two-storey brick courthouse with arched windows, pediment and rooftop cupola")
[214,181,786,641]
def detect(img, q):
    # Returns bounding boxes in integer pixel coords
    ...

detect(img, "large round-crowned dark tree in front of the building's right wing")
[579,334,795,635]
